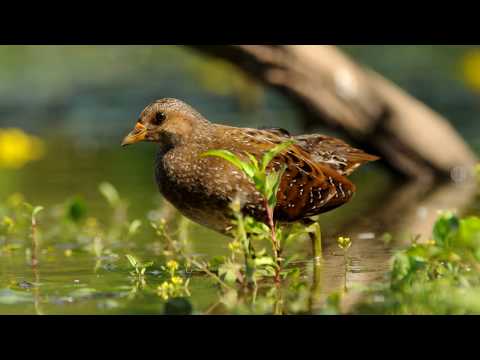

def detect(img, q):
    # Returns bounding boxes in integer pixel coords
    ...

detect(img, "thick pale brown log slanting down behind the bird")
[190,45,476,180]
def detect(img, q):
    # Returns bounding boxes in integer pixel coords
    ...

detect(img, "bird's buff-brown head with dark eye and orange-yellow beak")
[122,98,208,147]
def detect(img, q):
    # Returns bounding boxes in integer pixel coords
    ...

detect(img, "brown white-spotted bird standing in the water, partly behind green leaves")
[122,98,378,233]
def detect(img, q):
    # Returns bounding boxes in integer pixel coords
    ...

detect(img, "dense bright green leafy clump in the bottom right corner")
[354,212,480,314]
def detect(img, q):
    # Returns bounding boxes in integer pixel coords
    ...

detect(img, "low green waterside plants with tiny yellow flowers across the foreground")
[7,172,480,314]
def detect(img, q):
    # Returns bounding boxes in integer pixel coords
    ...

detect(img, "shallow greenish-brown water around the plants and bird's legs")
[0,136,416,314]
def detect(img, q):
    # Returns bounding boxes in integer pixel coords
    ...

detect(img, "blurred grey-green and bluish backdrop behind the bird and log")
[0,45,480,147]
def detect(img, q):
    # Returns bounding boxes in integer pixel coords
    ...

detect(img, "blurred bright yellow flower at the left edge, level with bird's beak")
[0,129,45,169]
